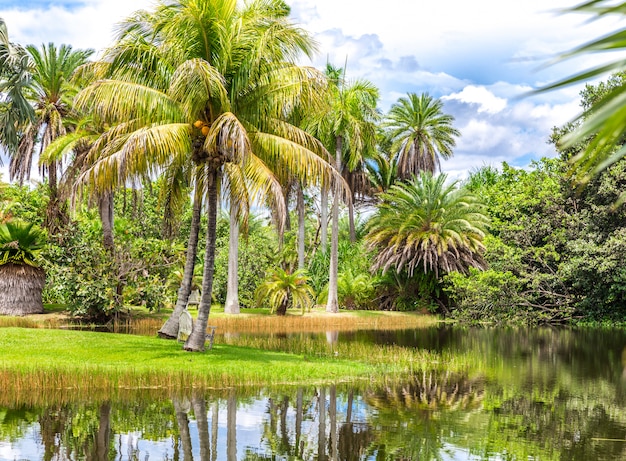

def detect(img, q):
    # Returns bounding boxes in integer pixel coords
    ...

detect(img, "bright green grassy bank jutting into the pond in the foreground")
[0,327,466,392]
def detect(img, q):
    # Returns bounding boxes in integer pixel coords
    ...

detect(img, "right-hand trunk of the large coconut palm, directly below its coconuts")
[184,169,219,352]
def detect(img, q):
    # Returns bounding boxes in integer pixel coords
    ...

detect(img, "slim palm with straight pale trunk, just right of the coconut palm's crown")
[308,66,378,312]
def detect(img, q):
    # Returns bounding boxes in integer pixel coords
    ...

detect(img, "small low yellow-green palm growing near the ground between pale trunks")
[255,268,313,315]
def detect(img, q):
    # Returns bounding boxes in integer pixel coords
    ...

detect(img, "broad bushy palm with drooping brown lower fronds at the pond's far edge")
[366,172,489,278]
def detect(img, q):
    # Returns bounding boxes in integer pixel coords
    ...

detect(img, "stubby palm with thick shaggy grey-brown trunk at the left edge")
[0,221,46,315]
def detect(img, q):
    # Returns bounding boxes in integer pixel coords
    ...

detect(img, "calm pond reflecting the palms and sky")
[0,327,626,461]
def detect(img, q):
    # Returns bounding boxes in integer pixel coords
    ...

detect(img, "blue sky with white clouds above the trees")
[0,0,624,178]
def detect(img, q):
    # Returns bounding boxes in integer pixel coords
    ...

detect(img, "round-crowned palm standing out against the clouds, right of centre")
[384,93,460,180]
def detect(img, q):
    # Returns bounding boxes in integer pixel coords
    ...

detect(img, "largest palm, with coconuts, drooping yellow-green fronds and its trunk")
[76,0,342,351]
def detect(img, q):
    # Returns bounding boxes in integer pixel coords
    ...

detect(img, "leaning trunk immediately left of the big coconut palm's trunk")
[157,191,202,339]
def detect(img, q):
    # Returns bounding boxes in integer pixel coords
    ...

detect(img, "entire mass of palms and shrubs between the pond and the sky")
[0,5,626,326]
